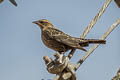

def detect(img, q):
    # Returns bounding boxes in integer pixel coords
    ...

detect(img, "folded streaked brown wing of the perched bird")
[48,28,86,51]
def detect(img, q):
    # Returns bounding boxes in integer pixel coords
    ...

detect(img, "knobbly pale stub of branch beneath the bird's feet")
[43,52,76,80]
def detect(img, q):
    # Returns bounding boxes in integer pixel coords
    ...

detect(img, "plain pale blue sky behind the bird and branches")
[0,0,120,80]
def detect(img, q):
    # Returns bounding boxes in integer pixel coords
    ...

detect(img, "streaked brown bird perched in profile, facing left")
[33,19,106,53]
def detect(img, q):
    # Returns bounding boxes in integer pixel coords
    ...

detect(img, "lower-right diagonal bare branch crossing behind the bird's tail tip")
[75,18,120,70]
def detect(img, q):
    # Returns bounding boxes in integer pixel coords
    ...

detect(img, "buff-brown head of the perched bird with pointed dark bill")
[32,19,54,29]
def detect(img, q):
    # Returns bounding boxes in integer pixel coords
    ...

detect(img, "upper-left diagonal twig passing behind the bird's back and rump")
[68,0,112,59]
